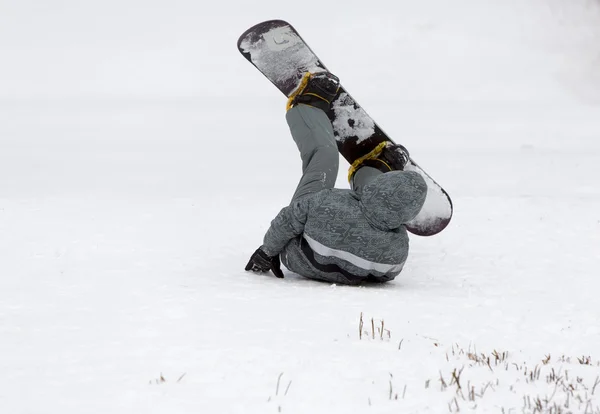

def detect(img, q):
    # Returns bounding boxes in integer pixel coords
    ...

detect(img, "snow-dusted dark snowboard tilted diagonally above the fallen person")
[237,20,453,236]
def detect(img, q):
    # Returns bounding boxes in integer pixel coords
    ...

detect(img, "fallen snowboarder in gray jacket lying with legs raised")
[245,72,427,284]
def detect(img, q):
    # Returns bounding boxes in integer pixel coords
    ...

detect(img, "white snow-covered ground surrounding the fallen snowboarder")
[0,0,600,414]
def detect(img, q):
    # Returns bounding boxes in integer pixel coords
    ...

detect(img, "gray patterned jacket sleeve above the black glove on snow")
[261,197,314,256]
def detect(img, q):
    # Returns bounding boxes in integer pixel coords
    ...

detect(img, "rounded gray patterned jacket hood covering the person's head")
[360,171,427,230]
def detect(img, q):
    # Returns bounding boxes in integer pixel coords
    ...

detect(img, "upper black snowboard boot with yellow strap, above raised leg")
[287,72,340,112]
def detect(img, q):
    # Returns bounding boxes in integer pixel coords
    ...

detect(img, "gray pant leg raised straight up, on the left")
[286,105,339,201]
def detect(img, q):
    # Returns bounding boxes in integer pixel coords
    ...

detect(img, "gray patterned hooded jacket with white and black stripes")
[261,171,427,284]
